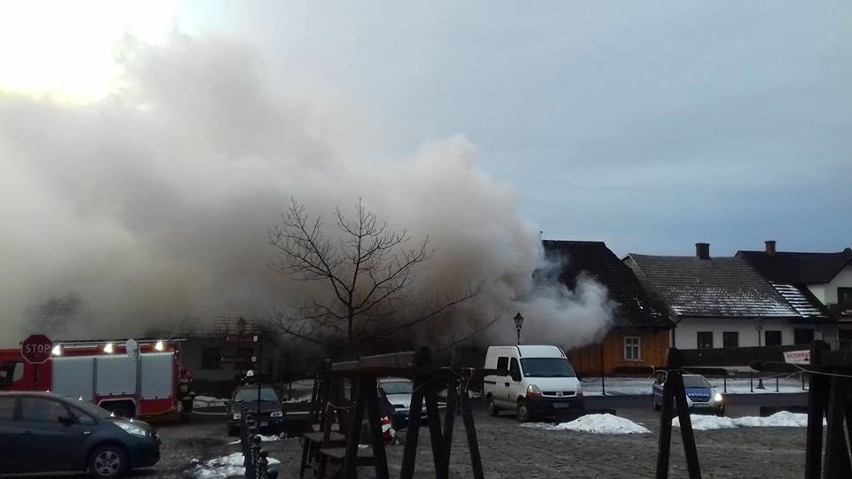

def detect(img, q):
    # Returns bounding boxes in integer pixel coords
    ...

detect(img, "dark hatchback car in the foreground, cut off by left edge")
[0,392,160,478]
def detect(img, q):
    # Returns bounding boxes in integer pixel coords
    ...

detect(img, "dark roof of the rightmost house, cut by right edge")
[737,248,852,284]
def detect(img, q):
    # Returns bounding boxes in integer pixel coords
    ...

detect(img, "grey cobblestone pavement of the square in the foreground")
[4,401,805,479]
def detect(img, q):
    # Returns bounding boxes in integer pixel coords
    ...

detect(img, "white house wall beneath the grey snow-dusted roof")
[672,318,821,349]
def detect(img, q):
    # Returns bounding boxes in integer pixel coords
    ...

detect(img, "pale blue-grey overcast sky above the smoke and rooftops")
[175,0,852,256]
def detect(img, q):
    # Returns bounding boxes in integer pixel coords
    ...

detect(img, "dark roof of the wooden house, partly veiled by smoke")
[543,240,671,327]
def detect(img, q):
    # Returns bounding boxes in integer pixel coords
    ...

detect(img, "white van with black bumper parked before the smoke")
[483,345,584,421]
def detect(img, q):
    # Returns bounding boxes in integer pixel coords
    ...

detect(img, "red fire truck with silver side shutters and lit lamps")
[0,340,183,419]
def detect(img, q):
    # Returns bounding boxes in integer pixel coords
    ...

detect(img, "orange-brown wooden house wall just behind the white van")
[568,329,669,376]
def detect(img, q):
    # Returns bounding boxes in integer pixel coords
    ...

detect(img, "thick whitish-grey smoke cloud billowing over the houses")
[0,35,610,346]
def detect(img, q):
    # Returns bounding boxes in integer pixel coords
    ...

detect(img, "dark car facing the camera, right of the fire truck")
[228,384,284,436]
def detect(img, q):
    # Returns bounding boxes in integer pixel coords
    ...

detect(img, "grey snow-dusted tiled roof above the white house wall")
[625,254,800,319]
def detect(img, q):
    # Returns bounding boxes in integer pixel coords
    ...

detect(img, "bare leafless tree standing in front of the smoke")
[268,199,478,352]
